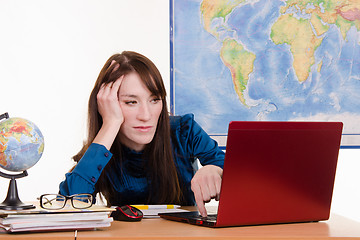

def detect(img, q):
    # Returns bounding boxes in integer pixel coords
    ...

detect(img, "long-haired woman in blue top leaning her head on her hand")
[60,51,224,216]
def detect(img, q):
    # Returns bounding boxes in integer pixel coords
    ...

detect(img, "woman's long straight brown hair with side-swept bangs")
[73,51,182,205]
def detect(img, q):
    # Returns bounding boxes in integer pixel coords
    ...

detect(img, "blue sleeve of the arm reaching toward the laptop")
[176,114,225,168]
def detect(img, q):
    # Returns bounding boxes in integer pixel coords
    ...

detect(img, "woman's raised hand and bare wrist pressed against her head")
[93,76,124,149]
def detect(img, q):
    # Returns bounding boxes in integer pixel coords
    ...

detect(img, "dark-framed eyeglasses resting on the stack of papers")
[39,193,93,210]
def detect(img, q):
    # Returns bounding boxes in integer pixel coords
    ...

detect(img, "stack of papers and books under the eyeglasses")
[0,205,114,232]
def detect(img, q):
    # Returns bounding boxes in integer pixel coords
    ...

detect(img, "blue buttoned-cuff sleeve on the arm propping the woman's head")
[59,143,112,196]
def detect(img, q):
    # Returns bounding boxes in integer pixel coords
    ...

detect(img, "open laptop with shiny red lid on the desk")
[159,121,343,227]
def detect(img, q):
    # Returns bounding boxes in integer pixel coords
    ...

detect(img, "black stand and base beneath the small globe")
[0,170,35,210]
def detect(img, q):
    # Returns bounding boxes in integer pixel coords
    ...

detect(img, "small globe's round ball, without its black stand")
[0,118,44,172]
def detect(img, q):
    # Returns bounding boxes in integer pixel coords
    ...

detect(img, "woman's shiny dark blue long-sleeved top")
[60,114,225,206]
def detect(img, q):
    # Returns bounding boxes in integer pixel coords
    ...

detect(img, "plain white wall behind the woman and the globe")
[0,0,360,221]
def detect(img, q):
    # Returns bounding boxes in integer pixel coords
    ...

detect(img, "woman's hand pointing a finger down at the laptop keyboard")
[191,165,223,217]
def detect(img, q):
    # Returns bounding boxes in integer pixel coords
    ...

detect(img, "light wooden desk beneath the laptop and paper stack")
[0,214,360,240]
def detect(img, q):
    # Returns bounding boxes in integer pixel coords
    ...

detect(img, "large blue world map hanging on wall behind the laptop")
[170,0,360,148]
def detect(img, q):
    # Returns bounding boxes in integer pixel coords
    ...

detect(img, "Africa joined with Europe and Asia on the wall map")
[271,0,360,82]
